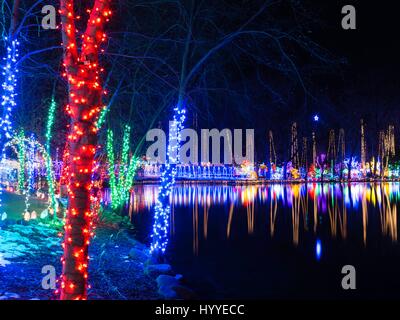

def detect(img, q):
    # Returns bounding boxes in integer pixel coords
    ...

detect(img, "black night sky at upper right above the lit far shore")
[266,0,400,159]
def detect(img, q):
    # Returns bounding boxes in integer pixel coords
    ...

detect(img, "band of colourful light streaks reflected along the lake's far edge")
[104,183,400,248]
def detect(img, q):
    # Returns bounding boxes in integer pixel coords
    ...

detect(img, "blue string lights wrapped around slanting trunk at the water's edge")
[150,107,186,255]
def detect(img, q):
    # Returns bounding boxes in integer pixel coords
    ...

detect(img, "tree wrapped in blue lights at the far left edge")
[0,0,60,218]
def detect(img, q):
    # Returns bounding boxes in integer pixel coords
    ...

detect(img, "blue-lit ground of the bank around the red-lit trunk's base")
[0,221,159,300]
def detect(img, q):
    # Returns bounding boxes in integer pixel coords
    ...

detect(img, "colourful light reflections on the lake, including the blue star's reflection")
[104,183,400,254]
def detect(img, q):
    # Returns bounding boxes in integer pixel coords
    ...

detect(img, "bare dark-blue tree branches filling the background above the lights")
[0,0,397,175]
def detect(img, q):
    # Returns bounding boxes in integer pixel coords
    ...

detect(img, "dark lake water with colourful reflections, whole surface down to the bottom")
[108,183,400,299]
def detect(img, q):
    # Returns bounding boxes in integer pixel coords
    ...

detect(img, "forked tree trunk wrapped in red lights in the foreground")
[60,0,111,300]
